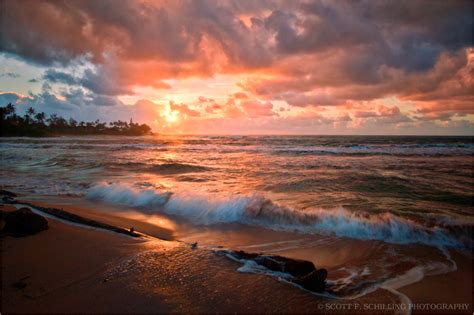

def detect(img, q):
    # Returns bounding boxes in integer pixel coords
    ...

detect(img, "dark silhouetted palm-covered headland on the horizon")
[0,103,151,137]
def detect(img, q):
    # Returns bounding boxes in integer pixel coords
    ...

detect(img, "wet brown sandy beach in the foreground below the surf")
[0,201,472,314]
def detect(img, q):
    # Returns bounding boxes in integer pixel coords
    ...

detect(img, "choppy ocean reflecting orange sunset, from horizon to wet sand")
[0,135,474,298]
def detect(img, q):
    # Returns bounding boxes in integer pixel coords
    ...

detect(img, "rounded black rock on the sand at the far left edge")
[2,208,48,236]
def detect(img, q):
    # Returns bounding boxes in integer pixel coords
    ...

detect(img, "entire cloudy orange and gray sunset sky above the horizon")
[0,0,474,135]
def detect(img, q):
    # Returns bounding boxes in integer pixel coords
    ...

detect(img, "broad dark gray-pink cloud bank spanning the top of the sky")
[0,0,473,81]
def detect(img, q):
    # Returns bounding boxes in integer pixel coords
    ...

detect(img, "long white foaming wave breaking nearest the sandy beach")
[86,184,472,248]
